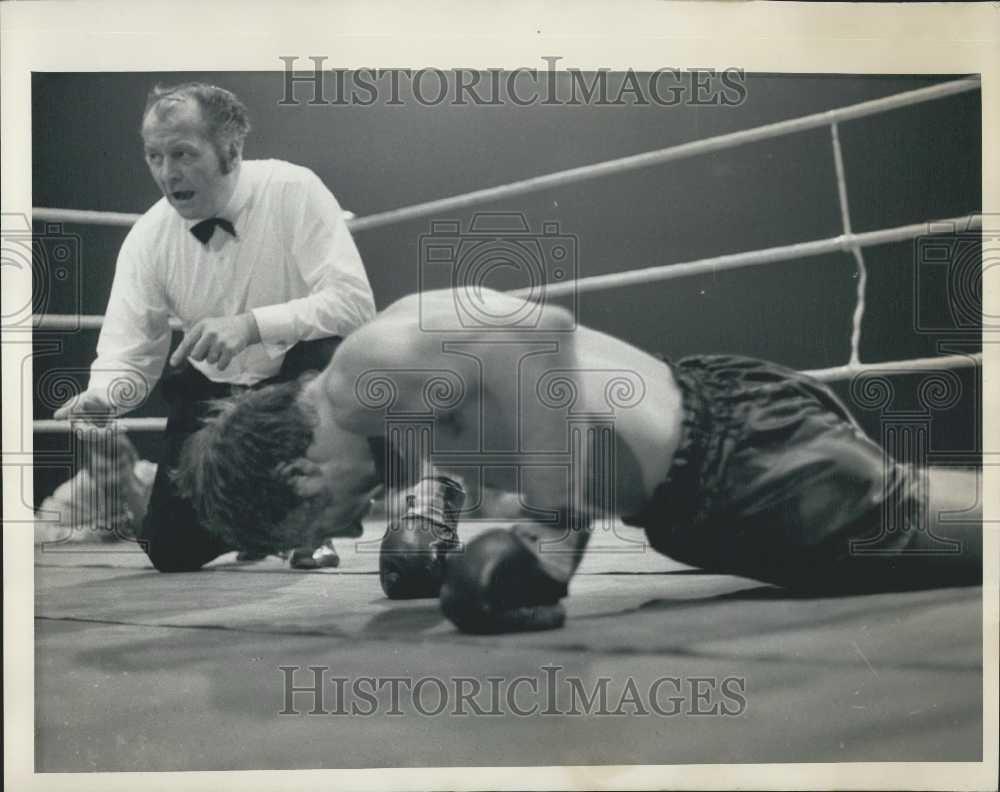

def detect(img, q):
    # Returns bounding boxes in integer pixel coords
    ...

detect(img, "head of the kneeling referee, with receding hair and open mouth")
[141,83,250,220]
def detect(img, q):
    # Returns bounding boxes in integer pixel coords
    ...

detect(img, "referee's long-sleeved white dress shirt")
[88,160,375,412]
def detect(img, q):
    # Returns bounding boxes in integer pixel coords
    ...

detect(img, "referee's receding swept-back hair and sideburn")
[142,82,250,173]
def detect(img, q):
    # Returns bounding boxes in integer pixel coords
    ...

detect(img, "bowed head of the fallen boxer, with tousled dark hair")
[174,376,376,553]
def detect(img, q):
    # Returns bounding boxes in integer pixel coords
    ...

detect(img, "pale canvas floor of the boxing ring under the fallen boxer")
[34,522,983,772]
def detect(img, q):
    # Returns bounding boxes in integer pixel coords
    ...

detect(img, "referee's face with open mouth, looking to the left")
[142,102,239,220]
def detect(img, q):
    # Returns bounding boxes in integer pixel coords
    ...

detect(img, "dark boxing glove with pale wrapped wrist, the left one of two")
[379,476,465,599]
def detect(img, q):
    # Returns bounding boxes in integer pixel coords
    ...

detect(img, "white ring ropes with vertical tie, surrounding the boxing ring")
[32,77,982,432]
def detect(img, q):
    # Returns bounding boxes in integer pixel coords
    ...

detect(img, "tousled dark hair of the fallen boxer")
[172,379,322,553]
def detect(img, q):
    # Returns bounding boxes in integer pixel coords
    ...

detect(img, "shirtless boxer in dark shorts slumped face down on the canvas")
[177,290,982,632]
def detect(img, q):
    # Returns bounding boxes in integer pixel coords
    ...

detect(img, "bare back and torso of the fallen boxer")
[310,290,681,516]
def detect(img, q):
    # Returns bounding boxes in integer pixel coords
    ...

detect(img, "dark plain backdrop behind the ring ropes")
[32,72,982,502]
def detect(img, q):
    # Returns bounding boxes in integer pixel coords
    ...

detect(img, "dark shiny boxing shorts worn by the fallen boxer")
[624,355,952,592]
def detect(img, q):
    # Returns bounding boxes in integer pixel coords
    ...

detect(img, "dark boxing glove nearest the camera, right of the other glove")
[441,528,567,634]
